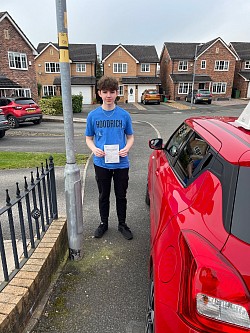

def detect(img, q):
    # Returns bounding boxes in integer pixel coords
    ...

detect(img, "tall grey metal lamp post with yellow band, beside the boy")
[56,0,83,260]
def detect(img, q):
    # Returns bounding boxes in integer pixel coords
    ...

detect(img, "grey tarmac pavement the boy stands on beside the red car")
[26,113,156,333]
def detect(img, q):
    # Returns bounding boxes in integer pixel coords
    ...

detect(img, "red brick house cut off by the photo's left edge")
[0,12,38,100]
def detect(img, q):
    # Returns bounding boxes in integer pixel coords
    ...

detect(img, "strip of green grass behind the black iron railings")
[0,152,89,170]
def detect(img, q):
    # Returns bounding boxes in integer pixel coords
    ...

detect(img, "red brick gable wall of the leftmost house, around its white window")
[0,18,38,100]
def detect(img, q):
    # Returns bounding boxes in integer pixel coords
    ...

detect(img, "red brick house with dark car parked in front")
[160,38,238,100]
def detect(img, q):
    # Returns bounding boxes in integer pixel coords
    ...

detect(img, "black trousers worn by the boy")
[94,165,129,224]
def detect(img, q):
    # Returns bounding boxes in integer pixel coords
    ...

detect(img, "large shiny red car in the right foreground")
[146,117,250,333]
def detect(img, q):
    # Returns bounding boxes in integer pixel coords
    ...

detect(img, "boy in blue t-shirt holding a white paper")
[85,76,134,240]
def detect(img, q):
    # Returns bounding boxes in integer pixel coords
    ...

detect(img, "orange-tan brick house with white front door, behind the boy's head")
[102,44,161,103]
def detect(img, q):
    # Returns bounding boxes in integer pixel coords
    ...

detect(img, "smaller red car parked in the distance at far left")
[0,97,42,128]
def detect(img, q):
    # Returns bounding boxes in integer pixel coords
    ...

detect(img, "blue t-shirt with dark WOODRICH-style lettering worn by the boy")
[85,105,134,169]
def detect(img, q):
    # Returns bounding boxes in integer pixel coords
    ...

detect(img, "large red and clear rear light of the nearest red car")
[179,232,250,333]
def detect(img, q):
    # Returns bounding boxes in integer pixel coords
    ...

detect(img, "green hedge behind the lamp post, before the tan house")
[39,95,83,116]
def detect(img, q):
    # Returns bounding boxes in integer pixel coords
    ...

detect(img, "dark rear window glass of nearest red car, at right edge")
[231,167,250,244]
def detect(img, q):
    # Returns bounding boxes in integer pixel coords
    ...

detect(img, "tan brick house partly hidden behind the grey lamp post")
[35,43,97,104]
